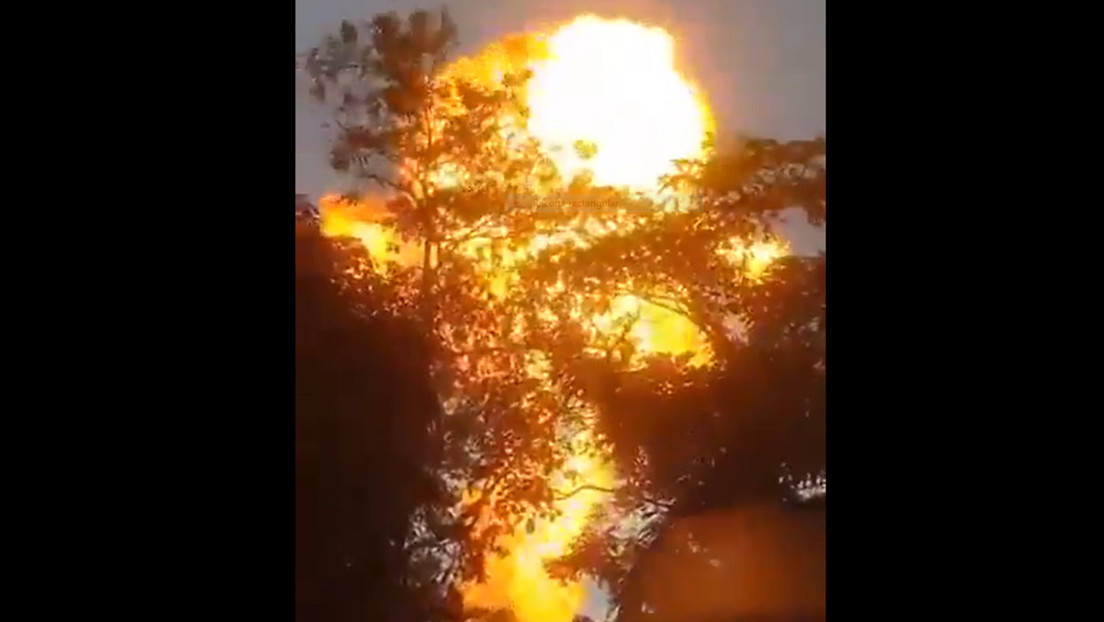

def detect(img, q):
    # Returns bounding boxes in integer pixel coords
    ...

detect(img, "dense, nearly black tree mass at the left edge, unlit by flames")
[295,223,448,622]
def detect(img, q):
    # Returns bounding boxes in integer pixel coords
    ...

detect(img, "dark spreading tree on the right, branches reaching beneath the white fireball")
[526,140,826,619]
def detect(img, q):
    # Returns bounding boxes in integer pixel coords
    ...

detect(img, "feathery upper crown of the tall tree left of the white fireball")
[306,10,554,333]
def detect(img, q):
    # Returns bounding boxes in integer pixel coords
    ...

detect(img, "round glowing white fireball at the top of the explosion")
[527,15,712,190]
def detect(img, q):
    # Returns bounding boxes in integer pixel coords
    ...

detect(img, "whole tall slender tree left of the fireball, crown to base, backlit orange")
[306,11,604,596]
